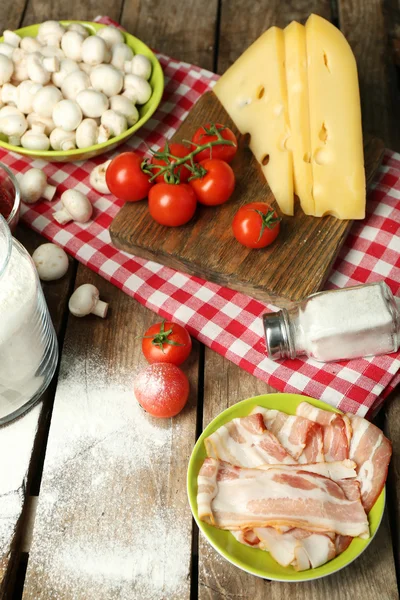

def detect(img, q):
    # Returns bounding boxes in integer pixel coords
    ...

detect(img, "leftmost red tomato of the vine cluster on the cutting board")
[106,152,153,202]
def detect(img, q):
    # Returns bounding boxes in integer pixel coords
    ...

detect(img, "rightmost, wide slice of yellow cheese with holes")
[306,15,365,219]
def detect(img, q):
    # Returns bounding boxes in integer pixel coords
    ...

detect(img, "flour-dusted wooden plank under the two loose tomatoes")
[24,268,198,600]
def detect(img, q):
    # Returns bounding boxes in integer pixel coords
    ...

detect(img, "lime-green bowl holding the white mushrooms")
[0,21,164,162]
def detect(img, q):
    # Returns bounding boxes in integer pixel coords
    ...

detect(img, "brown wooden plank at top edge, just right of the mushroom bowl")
[121,0,218,70]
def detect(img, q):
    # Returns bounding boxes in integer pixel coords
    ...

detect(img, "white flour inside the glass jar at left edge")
[0,240,43,417]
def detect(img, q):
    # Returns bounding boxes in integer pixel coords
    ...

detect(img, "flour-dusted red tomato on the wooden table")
[133,363,189,418]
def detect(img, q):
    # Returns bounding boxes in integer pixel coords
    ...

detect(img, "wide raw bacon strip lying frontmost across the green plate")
[198,458,369,537]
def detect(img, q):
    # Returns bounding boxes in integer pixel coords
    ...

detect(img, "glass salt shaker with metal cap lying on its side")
[263,281,400,362]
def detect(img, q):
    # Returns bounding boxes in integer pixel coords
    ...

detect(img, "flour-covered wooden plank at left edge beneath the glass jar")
[0,227,74,597]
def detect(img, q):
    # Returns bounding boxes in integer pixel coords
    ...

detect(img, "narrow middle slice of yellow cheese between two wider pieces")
[284,21,314,215]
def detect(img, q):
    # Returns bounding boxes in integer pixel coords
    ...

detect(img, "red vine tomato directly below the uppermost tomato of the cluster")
[189,158,235,206]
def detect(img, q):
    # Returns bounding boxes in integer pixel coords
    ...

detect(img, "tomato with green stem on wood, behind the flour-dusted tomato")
[142,321,192,365]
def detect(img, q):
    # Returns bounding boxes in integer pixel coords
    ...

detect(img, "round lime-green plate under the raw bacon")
[187,394,385,581]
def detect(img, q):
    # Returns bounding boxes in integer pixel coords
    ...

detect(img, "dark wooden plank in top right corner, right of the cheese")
[338,0,400,150]
